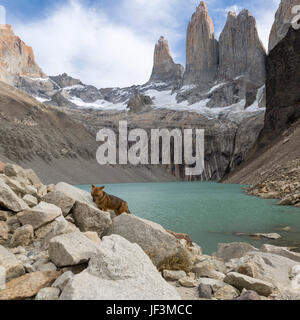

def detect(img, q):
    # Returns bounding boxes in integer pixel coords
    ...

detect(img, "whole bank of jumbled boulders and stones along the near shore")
[0,164,300,300]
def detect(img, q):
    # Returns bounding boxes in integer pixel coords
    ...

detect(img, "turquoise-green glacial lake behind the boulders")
[78,182,300,254]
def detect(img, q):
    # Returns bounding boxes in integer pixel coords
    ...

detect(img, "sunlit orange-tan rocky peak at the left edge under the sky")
[0,25,46,84]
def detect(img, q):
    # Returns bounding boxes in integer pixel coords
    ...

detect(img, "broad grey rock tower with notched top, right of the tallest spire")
[219,10,266,88]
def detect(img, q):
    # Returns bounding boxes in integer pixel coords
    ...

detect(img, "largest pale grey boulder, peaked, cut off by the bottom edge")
[60,235,180,301]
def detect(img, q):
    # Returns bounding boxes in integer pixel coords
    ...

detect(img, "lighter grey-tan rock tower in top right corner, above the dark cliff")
[269,0,299,52]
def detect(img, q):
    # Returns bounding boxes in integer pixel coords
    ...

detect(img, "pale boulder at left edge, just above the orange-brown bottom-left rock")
[0,245,25,281]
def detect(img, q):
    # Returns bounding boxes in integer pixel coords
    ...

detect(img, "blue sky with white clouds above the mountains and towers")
[0,0,280,87]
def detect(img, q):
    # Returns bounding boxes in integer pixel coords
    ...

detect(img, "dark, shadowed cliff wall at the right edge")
[258,27,300,147]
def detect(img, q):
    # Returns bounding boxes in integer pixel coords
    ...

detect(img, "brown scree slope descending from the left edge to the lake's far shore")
[0,82,174,184]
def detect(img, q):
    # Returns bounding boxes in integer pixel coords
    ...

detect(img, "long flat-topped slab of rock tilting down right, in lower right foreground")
[224,272,275,297]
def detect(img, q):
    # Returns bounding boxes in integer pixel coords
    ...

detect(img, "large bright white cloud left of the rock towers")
[15,0,154,87]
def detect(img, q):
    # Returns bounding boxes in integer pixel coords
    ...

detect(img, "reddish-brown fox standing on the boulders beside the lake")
[91,185,131,216]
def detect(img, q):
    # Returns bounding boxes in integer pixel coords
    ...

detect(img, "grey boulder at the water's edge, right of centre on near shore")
[216,242,258,262]
